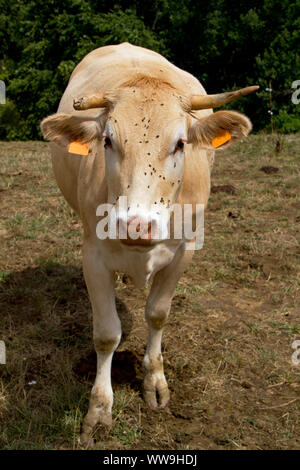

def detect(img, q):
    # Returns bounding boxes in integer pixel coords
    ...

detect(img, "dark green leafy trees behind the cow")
[0,0,300,140]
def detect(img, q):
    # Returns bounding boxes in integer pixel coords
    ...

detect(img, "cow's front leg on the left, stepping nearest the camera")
[81,243,121,445]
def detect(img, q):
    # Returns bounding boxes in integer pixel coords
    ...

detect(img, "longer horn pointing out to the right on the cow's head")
[191,85,259,110]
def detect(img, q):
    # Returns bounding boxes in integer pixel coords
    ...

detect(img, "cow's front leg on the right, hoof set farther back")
[143,246,193,409]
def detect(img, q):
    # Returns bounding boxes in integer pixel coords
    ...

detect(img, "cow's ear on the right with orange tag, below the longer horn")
[188,111,252,149]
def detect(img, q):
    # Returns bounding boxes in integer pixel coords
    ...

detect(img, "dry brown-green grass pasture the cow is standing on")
[0,134,300,450]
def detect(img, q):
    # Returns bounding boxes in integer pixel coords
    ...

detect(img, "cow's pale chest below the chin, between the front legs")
[100,240,184,288]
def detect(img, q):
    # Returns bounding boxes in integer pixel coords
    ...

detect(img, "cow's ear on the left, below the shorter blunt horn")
[41,113,102,153]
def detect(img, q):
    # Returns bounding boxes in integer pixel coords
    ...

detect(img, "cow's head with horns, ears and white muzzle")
[41,75,258,245]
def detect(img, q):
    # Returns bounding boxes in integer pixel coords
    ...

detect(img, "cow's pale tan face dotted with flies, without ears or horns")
[103,87,188,244]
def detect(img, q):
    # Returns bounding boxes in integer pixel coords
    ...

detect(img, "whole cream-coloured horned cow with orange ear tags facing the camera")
[41,43,258,446]
